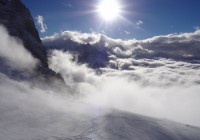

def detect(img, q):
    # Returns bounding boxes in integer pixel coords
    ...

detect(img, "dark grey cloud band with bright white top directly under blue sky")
[42,29,200,70]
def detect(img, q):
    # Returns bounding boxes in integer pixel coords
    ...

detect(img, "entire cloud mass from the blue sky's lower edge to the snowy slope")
[42,30,200,125]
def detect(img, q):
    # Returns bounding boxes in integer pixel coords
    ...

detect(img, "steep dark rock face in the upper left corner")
[0,0,48,67]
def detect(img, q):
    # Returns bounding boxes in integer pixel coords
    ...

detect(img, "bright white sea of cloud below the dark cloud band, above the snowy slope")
[50,50,200,126]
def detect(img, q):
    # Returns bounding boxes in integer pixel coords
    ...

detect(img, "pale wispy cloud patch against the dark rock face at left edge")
[0,26,38,71]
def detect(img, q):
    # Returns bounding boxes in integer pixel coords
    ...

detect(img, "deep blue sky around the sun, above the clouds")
[22,0,200,39]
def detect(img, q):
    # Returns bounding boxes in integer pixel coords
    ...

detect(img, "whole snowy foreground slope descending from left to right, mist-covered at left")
[0,75,200,140]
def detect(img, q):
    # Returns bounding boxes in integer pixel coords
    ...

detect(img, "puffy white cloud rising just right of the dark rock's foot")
[49,51,95,86]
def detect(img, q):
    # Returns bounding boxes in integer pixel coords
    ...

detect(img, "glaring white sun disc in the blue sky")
[97,0,121,21]
